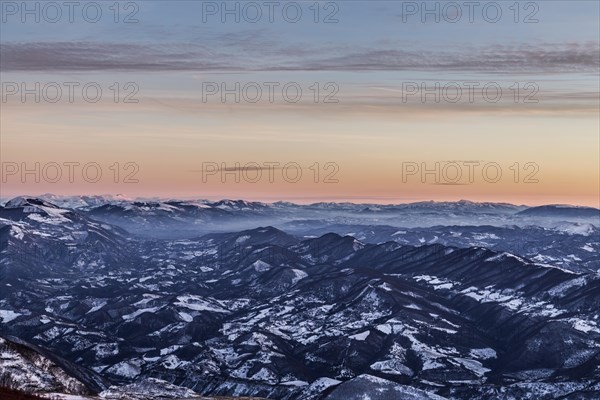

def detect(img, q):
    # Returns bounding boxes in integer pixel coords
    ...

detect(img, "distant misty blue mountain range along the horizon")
[5,195,600,238]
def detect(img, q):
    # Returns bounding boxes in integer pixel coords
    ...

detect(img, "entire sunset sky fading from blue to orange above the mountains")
[0,0,600,207]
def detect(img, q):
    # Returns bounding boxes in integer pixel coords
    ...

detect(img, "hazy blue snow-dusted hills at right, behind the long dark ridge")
[281,220,600,272]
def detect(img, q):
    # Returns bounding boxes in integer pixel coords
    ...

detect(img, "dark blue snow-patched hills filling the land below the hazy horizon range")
[0,198,600,400]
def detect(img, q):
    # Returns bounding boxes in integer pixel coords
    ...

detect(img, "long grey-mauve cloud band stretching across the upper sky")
[0,40,600,74]
